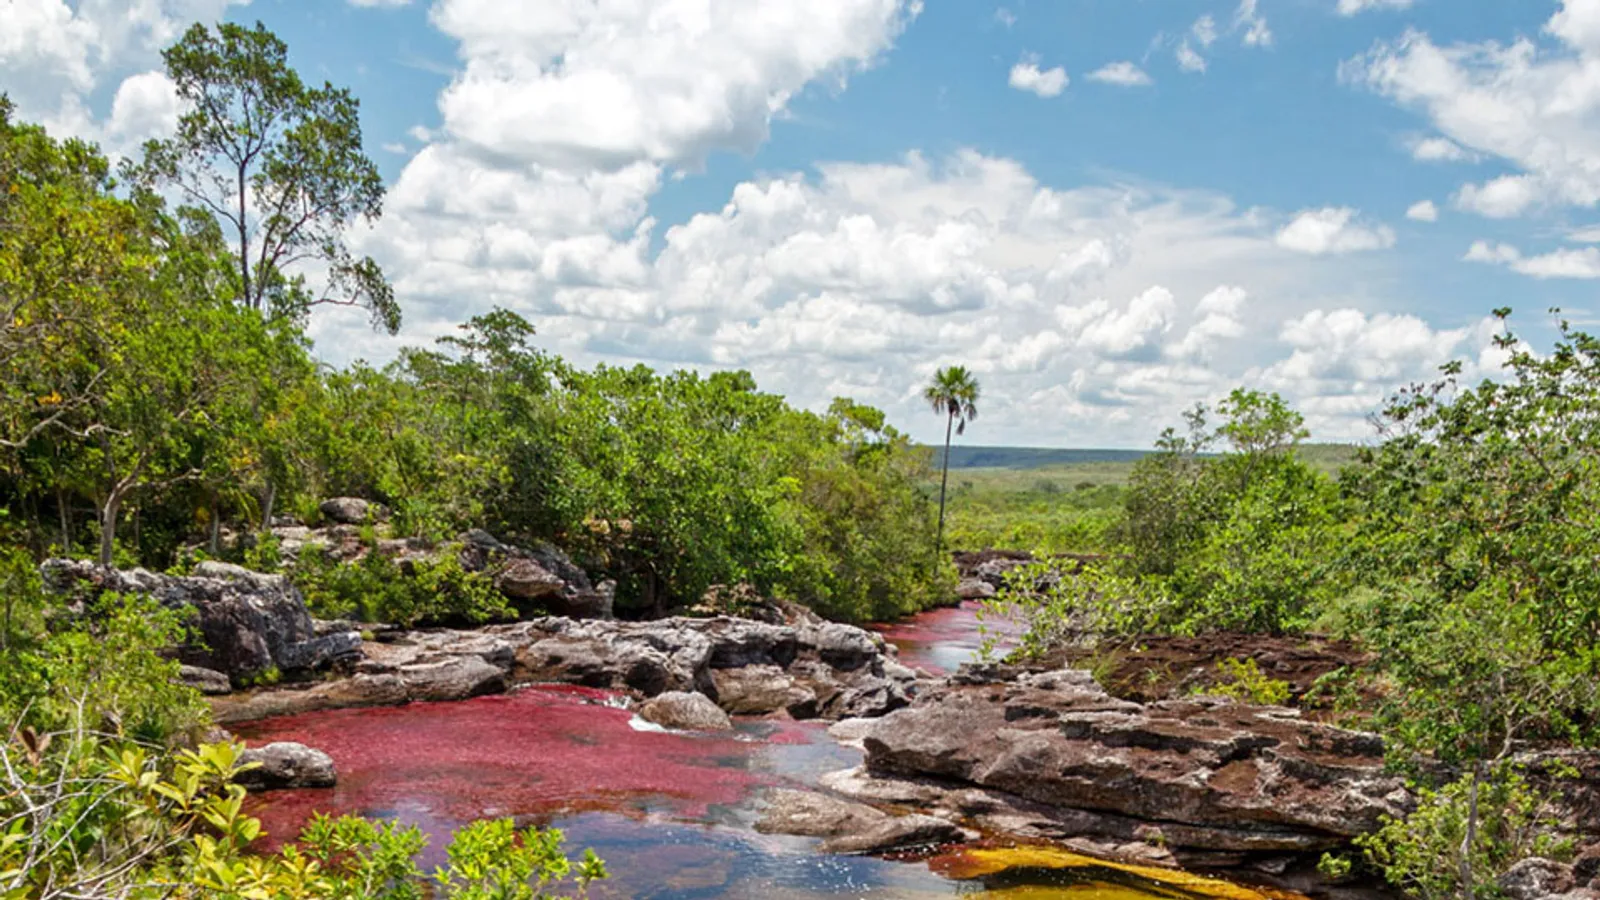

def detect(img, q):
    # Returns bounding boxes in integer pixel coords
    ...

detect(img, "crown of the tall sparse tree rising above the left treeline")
[136,22,400,333]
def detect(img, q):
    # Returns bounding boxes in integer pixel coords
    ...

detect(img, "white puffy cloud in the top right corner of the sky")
[1342,0,1600,218]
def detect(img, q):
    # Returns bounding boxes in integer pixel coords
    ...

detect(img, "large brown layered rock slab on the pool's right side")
[862,668,1410,852]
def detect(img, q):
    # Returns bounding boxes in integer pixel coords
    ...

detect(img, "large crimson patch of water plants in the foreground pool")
[238,687,819,844]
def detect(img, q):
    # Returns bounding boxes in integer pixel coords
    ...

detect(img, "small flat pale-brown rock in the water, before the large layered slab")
[755,790,974,854]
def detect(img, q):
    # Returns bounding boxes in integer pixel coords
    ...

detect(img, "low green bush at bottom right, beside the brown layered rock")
[1350,765,1573,900]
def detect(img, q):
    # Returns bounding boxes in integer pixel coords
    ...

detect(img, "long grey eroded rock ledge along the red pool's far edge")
[213,617,915,722]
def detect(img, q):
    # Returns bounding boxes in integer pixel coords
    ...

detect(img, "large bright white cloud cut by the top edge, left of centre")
[430,0,920,168]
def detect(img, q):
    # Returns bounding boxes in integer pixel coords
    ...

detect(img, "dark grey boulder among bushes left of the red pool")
[42,559,362,685]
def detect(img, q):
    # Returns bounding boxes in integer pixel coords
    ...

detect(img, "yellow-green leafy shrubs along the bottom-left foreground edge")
[0,730,605,900]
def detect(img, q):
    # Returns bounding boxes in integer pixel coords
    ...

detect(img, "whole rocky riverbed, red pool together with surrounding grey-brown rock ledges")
[46,556,1600,900]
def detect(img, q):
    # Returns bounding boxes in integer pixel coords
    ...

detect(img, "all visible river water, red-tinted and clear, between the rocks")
[237,607,1286,900]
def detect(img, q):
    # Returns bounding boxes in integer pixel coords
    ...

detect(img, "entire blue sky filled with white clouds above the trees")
[0,0,1600,447]
